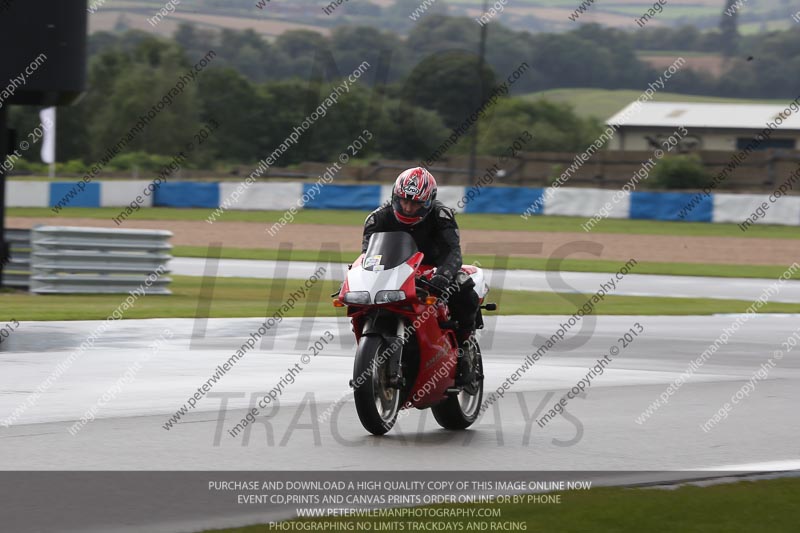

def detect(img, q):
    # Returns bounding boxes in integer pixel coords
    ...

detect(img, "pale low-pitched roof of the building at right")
[606,100,800,131]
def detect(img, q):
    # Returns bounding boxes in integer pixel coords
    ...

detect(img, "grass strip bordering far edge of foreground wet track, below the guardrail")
[0,276,800,320]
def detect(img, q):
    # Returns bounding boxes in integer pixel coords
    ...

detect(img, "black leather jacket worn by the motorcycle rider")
[361,200,461,279]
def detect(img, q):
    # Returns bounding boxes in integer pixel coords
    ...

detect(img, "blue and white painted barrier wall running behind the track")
[7,180,800,226]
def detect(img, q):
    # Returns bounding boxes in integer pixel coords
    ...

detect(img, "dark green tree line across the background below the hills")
[10,14,800,171]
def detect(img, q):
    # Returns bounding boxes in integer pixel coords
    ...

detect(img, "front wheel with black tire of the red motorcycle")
[353,335,400,435]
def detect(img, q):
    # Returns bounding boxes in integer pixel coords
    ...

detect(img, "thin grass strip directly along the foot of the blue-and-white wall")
[7,207,800,239]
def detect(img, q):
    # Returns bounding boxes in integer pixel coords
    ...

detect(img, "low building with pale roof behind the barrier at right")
[606,101,800,152]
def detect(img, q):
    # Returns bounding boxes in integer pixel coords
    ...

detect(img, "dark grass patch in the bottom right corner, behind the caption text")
[206,478,800,533]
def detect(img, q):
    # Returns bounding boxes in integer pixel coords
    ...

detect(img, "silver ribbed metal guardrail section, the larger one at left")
[20,226,172,294]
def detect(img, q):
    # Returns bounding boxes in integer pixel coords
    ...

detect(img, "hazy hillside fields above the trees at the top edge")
[89,0,793,35]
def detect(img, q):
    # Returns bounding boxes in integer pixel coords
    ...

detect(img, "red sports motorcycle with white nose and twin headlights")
[331,232,497,435]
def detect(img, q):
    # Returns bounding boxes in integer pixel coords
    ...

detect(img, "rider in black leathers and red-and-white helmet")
[361,167,480,386]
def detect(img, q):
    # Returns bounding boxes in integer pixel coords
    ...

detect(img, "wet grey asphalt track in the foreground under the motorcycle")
[0,315,800,470]
